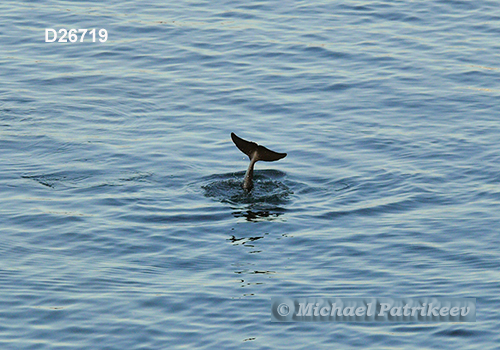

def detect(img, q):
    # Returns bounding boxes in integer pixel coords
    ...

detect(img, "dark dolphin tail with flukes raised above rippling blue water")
[231,132,286,192]
